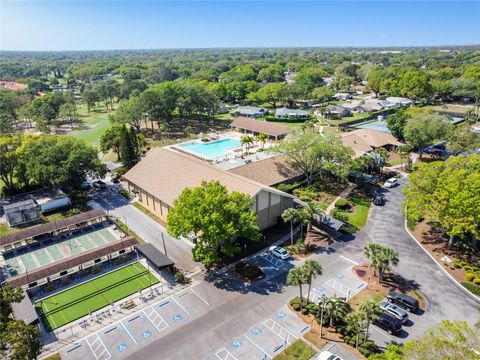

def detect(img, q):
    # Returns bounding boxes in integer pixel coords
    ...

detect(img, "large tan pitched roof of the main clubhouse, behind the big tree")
[123,148,289,206]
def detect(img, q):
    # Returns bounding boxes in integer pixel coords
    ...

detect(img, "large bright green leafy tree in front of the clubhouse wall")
[167,181,260,265]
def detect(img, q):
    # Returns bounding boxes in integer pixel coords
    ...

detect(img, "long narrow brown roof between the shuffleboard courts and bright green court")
[7,236,138,286]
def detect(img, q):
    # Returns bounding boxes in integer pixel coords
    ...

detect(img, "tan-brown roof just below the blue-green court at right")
[342,129,404,156]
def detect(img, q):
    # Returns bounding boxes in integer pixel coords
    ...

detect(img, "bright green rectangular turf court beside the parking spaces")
[35,262,159,330]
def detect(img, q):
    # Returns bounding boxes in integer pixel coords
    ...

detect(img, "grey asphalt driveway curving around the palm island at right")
[338,178,479,340]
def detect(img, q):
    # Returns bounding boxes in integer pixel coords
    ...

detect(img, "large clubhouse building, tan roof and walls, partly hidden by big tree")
[123,148,293,230]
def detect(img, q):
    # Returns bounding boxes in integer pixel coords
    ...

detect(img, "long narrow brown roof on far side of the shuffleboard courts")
[0,208,105,246]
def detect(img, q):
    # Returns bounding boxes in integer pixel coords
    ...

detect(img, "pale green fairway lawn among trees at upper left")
[69,104,114,147]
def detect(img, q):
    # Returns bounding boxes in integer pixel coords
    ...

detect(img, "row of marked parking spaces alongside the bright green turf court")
[61,288,210,360]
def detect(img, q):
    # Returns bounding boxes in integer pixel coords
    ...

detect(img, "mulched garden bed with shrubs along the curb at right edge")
[412,221,480,296]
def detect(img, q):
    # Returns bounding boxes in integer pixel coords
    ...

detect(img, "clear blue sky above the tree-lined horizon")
[0,0,480,50]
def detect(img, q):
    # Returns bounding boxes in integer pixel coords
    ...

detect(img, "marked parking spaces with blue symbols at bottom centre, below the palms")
[207,306,310,360]
